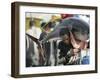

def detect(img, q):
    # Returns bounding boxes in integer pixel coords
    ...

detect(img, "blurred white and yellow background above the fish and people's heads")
[26,12,90,30]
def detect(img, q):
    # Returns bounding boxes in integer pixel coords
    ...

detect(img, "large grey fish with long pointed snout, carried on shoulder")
[42,17,90,42]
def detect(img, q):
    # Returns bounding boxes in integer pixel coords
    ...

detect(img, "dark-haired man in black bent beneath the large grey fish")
[58,28,73,65]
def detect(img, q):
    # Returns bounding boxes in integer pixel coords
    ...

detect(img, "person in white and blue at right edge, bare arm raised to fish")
[70,32,89,64]
